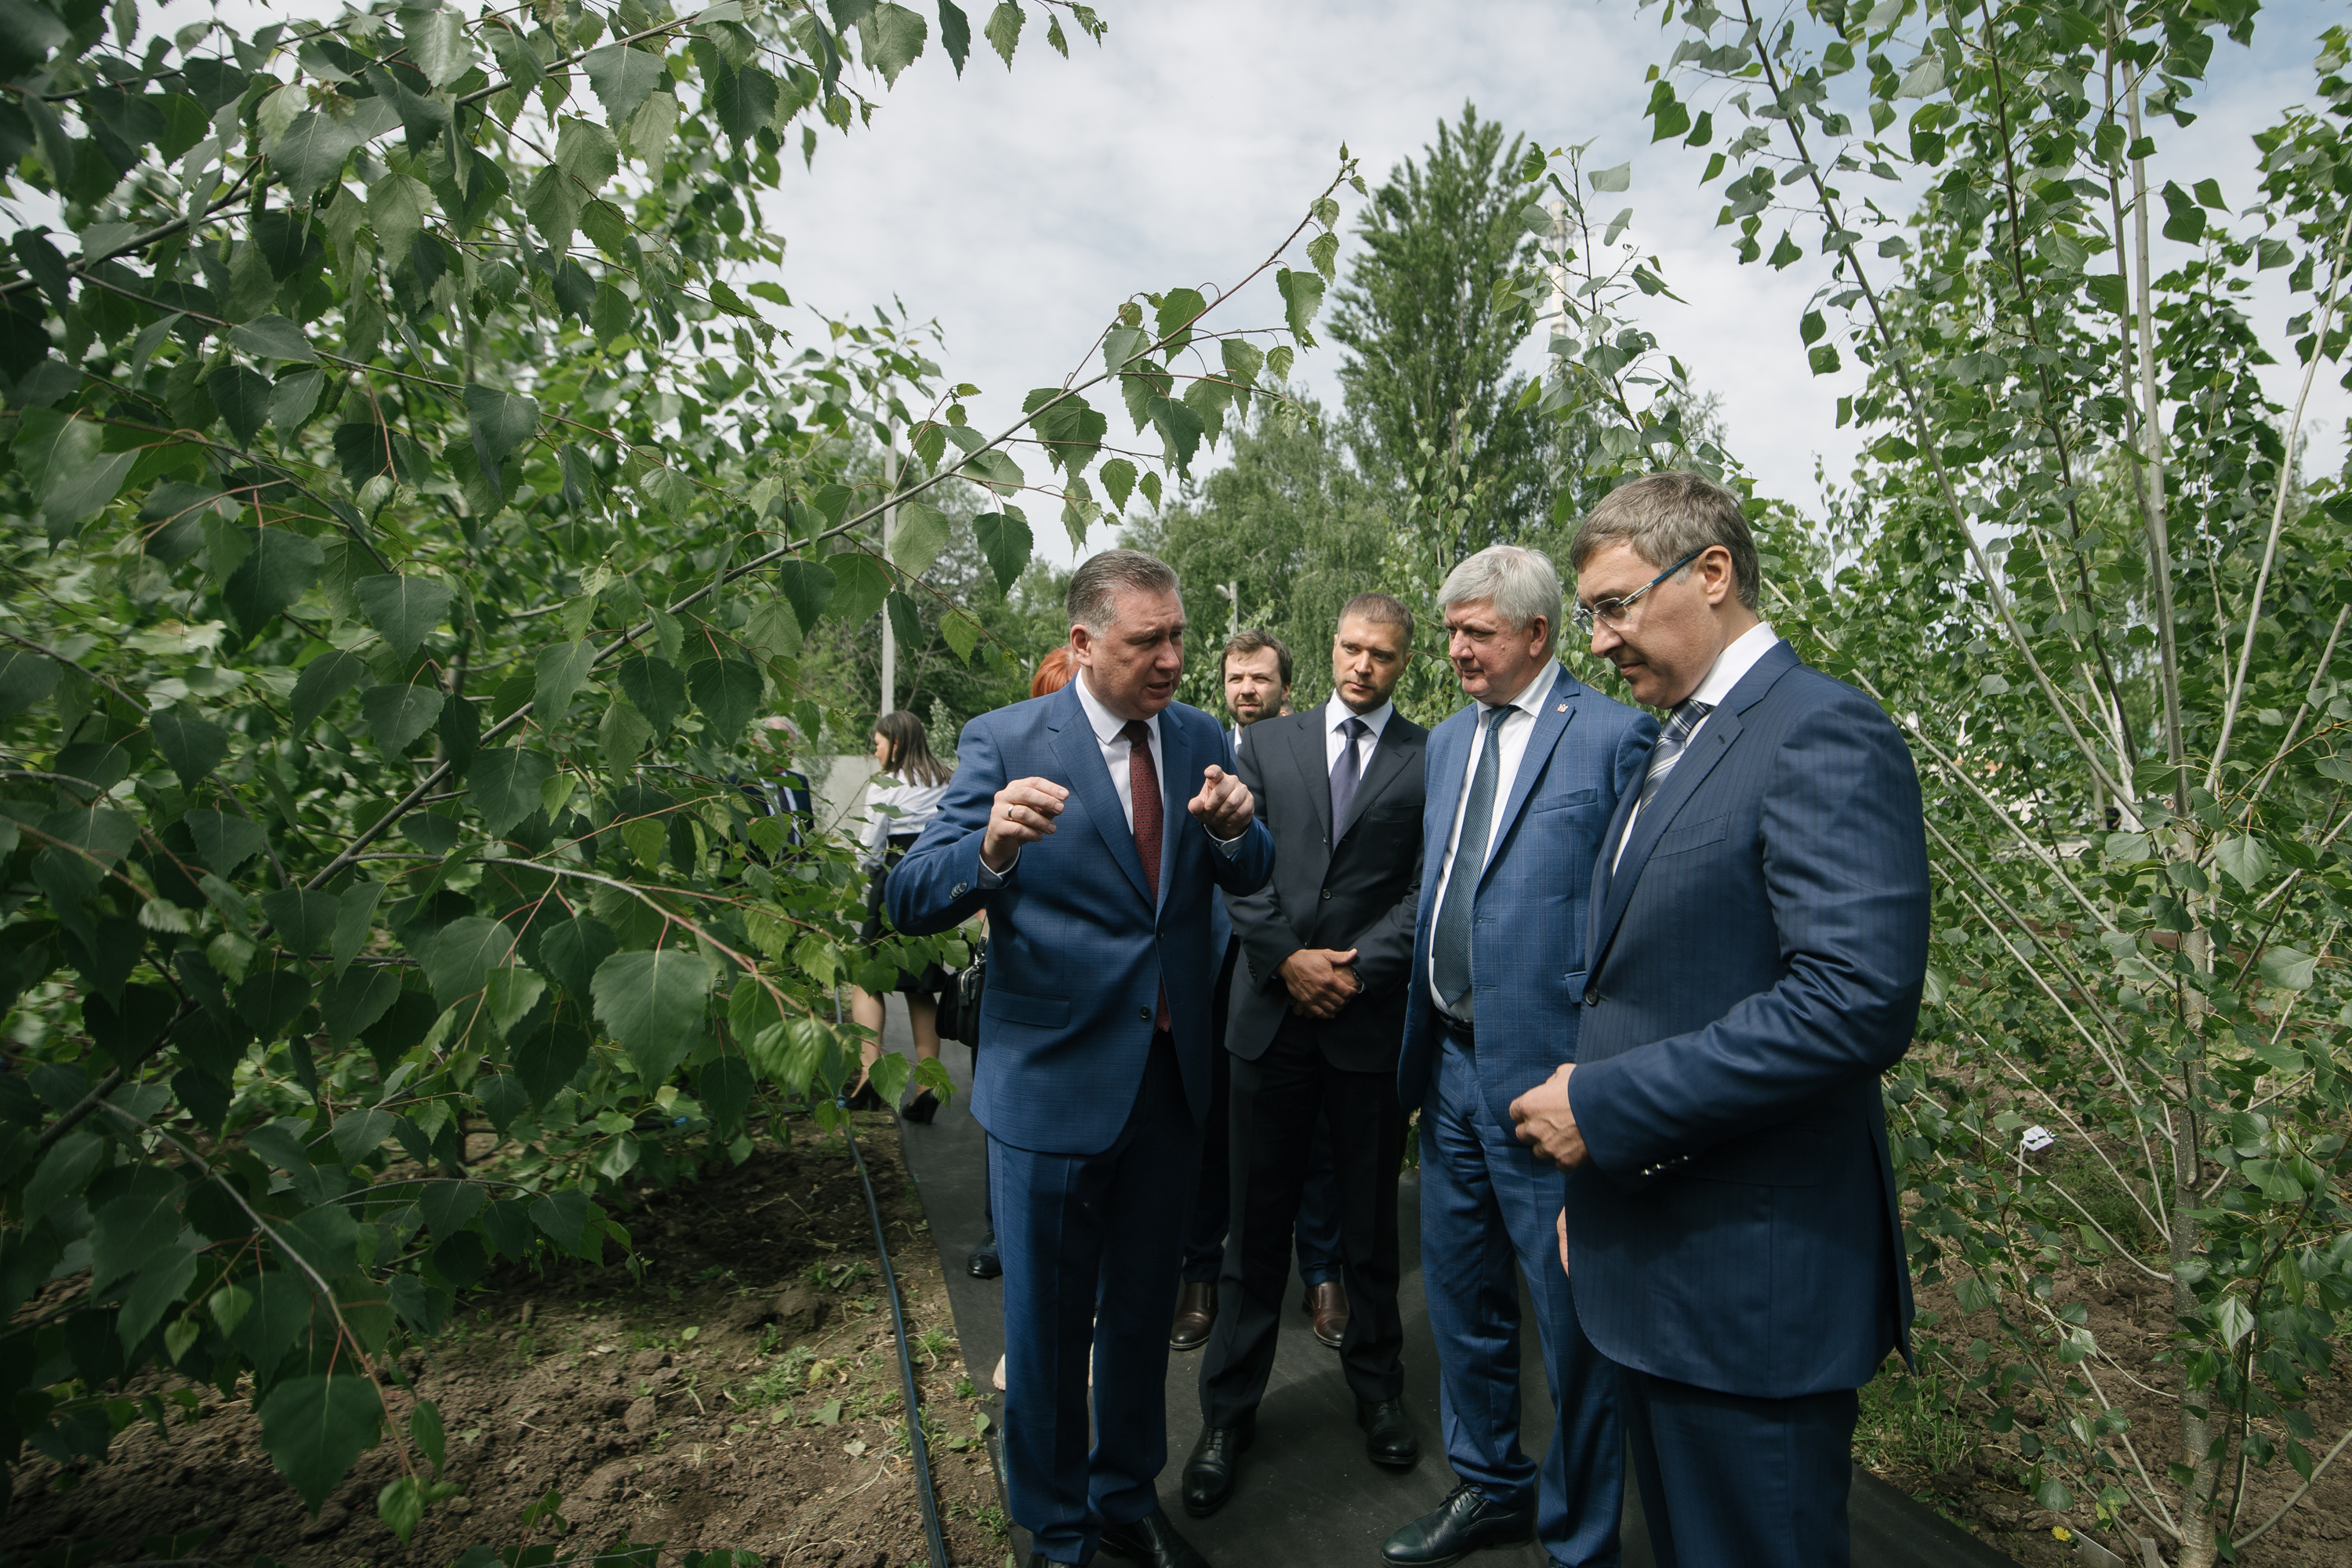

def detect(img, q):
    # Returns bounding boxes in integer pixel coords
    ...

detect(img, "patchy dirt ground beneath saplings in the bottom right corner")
[1856,1262,2352,1568]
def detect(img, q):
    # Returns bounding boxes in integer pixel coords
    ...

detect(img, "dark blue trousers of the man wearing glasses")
[1618,1366,1858,1568]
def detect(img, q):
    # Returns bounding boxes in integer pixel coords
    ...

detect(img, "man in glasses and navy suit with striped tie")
[1512,473,1929,1568]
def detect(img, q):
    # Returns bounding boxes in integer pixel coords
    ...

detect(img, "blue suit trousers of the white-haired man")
[1421,1034,1628,1568]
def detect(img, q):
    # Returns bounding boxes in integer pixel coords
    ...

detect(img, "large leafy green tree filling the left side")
[0,0,1352,1537]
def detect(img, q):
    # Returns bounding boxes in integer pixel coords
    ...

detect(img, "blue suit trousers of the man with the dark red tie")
[988,1032,1200,1563]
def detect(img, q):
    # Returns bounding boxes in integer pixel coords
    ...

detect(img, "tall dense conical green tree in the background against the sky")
[1331,103,1555,557]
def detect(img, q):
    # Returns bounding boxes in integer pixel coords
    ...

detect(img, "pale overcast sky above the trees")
[769,0,2347,560]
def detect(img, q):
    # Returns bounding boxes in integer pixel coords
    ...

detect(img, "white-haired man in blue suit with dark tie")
[1381,546,1658,1568]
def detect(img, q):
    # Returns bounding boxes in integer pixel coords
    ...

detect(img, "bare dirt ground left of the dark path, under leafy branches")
[0,1112,1007,1568]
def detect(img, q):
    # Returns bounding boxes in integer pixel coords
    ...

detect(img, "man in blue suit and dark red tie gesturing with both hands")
[887,550,1275,1568]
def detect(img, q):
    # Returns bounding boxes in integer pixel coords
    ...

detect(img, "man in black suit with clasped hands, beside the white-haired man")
[1183,593,1428,1516]
